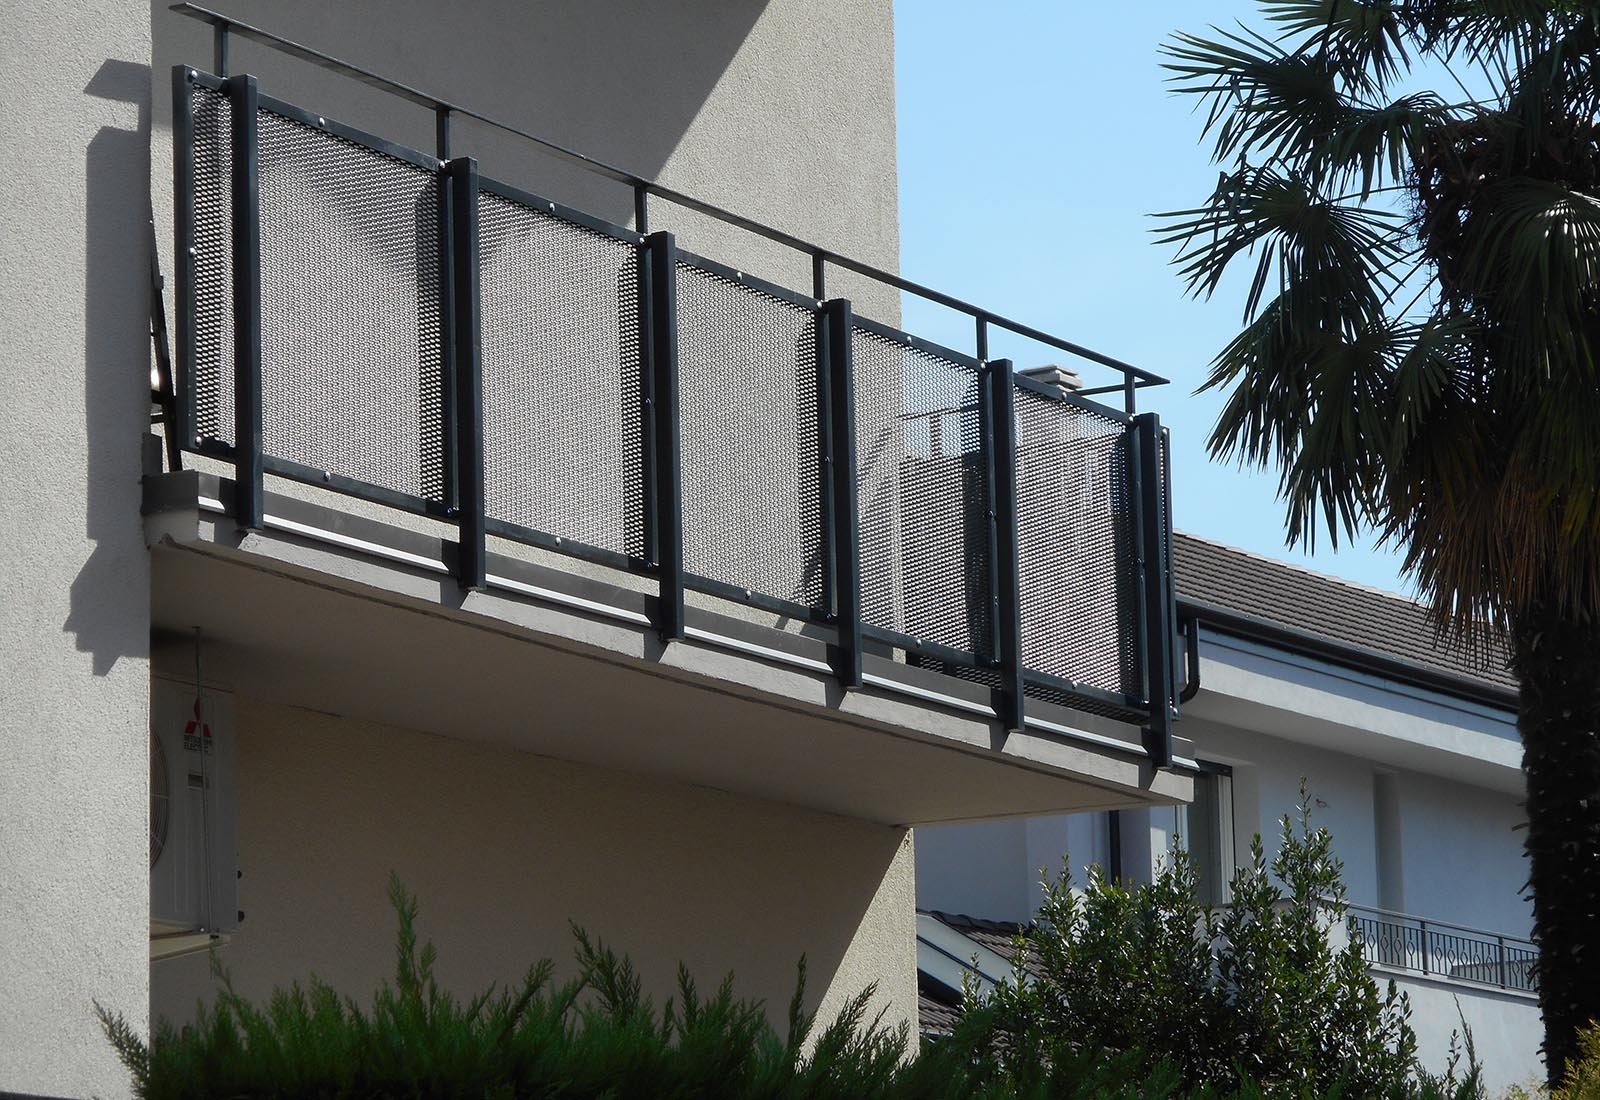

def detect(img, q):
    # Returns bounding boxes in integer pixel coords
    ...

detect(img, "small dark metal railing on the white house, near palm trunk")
[1349,905,1539,993]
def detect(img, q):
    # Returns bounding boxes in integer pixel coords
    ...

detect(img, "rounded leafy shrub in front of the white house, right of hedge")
[968,788,1440,1097]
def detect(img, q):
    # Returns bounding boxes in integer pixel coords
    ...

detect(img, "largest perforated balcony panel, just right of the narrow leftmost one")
[259,110,445,502]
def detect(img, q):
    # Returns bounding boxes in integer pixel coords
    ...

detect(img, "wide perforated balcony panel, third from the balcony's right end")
[677,262,826,608]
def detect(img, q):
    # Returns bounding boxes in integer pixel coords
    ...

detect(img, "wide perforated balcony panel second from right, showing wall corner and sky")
[851,328,994,657]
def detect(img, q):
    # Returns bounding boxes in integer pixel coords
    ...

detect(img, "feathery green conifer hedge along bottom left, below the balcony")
[101,878,955,1100]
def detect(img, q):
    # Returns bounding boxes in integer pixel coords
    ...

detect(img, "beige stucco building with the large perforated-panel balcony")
[0,0,1203,1097]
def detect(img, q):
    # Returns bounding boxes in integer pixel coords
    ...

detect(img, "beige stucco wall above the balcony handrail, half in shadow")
[150,0,899,323]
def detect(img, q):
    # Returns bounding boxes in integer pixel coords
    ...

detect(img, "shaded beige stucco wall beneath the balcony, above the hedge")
[152,697,917,1042]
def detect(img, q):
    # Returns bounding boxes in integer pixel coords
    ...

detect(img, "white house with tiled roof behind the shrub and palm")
[917,534,1542,1089]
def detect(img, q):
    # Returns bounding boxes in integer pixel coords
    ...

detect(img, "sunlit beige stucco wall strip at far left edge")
[0,0,150,1097]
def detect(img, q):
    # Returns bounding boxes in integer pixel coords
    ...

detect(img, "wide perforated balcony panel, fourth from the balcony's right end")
[478,190,645,558]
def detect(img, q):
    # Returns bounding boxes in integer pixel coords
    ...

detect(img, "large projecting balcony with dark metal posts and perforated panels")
[146,5,1187,820]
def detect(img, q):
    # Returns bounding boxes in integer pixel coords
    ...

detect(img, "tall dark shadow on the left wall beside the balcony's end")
[62,61,150,676]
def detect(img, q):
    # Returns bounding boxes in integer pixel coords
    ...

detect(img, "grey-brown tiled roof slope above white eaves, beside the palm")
[1173,532,1517,691]
